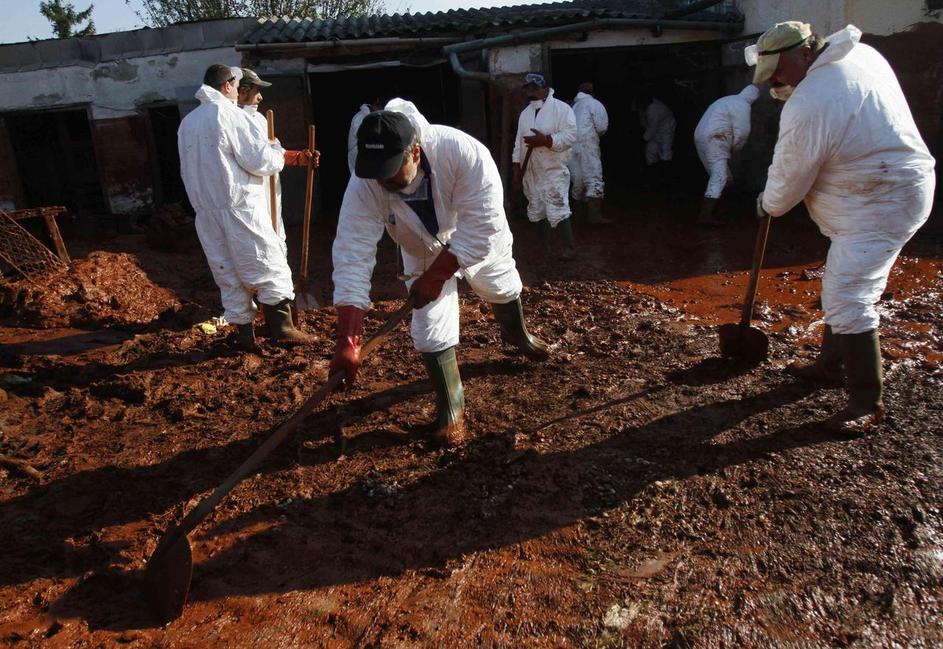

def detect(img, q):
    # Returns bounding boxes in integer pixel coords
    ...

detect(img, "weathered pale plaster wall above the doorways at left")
[0,47,240,119]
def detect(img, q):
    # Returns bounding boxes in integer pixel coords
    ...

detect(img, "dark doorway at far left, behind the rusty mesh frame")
[6,109,107,214]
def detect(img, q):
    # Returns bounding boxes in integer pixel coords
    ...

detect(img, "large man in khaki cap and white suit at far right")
[746,21,936,433]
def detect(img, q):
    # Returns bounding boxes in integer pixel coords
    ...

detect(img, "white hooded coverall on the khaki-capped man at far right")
[762,25,936,334]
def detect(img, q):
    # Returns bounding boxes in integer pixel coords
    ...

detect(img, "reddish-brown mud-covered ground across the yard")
[0,197,943,648]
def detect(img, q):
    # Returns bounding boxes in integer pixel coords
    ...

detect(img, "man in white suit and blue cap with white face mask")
[511,72,576,260]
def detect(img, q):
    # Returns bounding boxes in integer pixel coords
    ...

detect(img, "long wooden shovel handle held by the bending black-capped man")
[167,297,413,545]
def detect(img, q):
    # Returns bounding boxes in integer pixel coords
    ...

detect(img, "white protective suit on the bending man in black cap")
[333,99,522,352]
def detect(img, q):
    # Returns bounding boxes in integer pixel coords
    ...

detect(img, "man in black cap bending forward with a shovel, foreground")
[331,99,548,445]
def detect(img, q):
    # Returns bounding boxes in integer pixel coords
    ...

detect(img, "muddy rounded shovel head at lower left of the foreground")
[144,528,193,623]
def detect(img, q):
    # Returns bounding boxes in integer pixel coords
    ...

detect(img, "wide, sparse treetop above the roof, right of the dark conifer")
[134,0,385,27]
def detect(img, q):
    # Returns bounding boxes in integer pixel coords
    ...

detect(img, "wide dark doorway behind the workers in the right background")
[551,43,724,197]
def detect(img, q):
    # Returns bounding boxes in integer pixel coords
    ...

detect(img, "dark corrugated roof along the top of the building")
[241,0,743,45]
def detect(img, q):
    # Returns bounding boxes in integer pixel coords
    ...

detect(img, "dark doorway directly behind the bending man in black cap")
[310,64,461,215]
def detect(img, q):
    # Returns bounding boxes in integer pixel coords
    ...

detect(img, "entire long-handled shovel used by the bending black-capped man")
[144,298,413,623]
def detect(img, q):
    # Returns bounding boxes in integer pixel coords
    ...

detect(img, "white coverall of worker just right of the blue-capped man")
[570,92,609,200]
